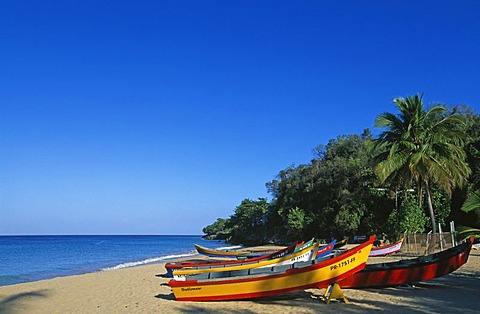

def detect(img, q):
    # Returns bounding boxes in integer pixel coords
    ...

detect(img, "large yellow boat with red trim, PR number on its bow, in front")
[168,236,375,301]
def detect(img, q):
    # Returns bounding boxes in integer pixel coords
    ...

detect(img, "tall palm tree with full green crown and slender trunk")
[373,95,470,233]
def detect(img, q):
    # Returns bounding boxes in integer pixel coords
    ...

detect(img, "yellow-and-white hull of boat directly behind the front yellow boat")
[173,241,318,280]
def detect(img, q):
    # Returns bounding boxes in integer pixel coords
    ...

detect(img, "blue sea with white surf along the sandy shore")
[0,235,236,286]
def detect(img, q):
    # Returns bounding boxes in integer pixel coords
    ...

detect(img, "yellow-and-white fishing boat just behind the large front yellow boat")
[173,239,319,280]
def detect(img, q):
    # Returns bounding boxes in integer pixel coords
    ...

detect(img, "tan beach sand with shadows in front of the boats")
[0,250,480,314]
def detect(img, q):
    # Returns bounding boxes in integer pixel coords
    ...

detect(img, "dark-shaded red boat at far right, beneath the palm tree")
[341,237,473,288]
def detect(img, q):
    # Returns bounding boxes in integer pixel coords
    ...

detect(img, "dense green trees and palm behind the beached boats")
[203,95,480,245]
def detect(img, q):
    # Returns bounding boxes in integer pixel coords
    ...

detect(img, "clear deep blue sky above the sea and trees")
[0,0,480,234]
